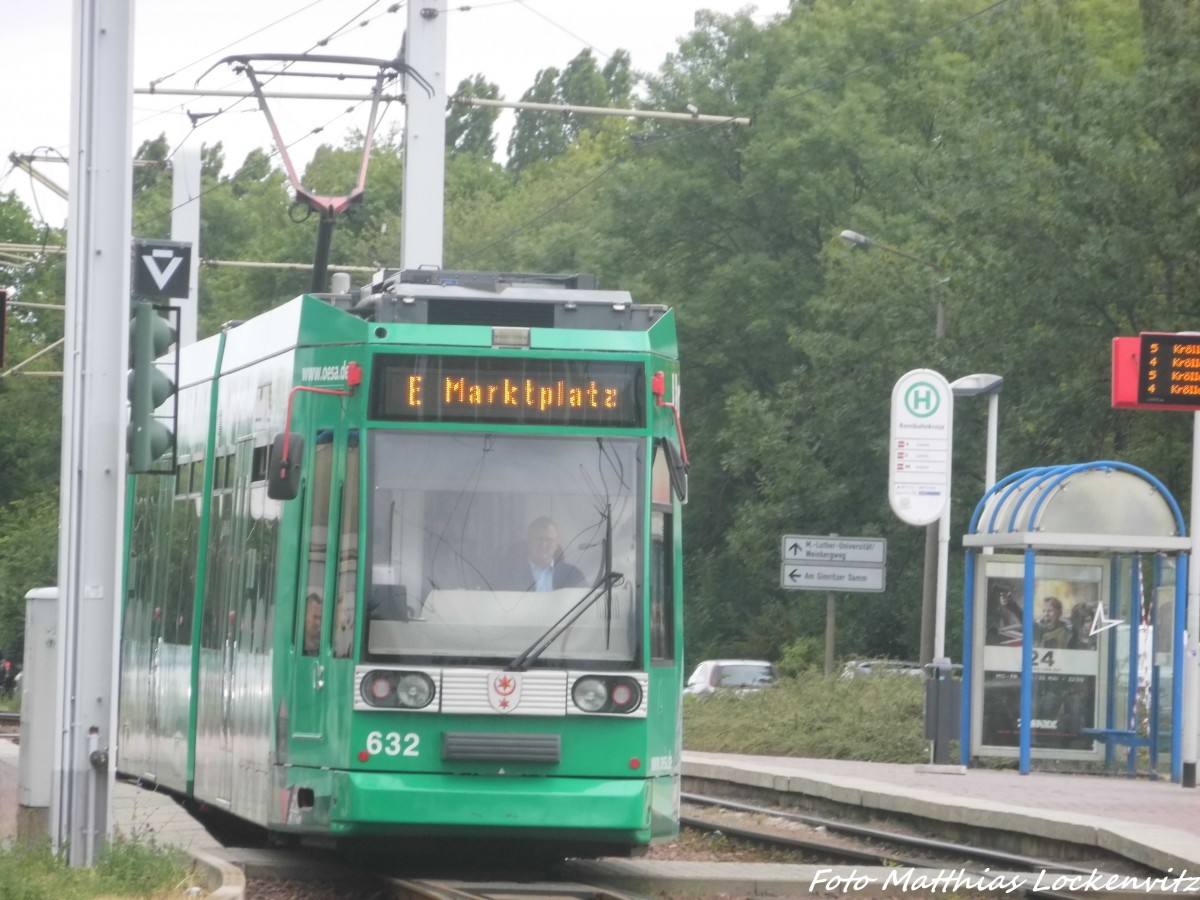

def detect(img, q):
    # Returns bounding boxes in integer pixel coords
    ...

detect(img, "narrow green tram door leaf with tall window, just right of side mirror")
[288,430,335,766]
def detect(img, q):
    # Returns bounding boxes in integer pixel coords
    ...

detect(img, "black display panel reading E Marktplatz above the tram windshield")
[371,355,646,427]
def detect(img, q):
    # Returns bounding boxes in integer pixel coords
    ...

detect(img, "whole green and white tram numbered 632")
[118,270,686,856]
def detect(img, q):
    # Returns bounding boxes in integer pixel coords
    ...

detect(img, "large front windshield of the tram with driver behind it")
[365,431,644,668]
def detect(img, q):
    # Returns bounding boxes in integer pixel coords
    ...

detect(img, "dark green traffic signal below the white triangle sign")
[126,300,179,474]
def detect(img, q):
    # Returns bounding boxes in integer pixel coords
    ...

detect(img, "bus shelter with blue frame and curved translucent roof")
[959,461,1190,781]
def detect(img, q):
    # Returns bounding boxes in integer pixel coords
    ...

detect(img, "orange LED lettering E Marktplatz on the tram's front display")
[404,374,620,412]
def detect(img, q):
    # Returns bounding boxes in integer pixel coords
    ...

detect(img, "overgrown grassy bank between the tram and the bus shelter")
[683,674,929,763]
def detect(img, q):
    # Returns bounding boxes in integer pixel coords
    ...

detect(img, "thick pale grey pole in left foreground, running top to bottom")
[50,0,133,866]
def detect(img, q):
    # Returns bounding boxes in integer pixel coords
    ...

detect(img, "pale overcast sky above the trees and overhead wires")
[0,0,787,226]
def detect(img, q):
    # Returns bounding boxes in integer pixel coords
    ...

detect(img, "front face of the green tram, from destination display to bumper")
[332,354,679,854]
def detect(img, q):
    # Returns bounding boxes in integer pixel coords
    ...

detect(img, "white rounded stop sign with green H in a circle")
[888,368,954,526]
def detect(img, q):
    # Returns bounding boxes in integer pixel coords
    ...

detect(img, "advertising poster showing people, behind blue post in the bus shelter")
[977,559,1105,758]
